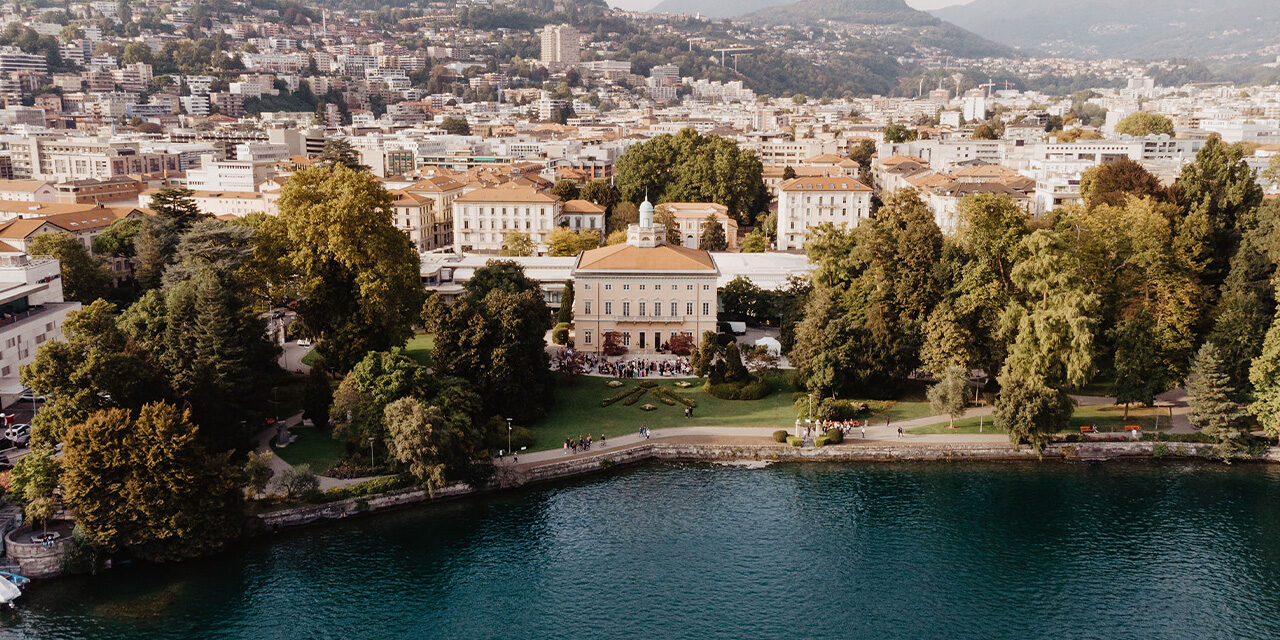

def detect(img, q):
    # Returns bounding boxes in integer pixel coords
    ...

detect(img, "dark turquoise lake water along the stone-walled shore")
[0,462,1280,640]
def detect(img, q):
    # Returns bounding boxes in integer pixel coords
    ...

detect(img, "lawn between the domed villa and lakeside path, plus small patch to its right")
[530,375,931,451]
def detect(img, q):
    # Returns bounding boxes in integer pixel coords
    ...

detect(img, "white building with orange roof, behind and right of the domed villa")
[777,177,872,251]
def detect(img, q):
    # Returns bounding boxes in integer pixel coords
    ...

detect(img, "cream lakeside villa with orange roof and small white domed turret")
[572,201,719,353]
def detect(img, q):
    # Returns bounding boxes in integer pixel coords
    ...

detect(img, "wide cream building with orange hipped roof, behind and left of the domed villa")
[453,184,562,253]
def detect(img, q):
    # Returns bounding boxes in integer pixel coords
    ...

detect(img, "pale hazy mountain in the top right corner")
[932,0,1280,58]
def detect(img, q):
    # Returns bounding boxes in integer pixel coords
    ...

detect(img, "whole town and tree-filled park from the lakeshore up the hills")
[0,0,1280,624]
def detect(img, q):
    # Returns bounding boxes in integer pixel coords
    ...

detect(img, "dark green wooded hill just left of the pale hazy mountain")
[747,0,1010,56]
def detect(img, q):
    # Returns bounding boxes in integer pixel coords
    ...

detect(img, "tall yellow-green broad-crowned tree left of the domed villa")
[279,166,424,371]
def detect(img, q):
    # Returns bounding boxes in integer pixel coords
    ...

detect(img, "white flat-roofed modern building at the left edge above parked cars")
[0,242,79,406]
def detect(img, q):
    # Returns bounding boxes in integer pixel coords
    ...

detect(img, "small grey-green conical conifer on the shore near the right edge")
[1187,342,1245,448]
